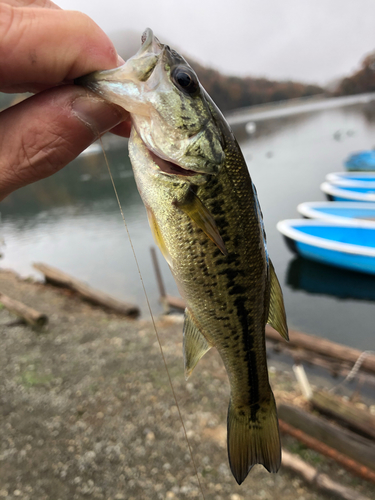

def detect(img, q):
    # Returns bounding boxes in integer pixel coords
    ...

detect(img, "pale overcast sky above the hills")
[55,0,375,84]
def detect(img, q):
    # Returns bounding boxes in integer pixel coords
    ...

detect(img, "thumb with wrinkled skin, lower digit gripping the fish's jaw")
[0,86,129,200]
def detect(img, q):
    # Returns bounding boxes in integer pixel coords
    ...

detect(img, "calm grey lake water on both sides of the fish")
[0,95,375,350]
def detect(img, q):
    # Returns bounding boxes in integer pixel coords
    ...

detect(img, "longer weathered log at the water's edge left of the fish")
[33,263,139,316]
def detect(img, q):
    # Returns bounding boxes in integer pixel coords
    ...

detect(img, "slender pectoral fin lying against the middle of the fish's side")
[176,190,228,255]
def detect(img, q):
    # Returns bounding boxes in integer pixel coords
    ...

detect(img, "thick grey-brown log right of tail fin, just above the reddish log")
[278,404,375,470]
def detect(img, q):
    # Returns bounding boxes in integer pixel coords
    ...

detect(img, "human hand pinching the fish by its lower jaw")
[0,0,130,200]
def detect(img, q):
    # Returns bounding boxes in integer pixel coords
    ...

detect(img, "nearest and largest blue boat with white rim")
[277,219,375,274]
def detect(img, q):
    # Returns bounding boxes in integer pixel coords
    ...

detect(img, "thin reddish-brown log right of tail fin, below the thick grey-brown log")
[279,418,375,483]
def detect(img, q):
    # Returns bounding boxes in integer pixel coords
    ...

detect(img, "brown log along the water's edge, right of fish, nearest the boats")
[266,325,375,373]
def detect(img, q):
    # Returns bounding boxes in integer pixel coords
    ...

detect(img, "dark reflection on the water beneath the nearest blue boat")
[286,257,375,301]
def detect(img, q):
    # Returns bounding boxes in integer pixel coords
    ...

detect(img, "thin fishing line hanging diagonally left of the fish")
[99,137,206,500]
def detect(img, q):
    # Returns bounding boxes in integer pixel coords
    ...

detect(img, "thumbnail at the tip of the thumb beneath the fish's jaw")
[72,97,128,136]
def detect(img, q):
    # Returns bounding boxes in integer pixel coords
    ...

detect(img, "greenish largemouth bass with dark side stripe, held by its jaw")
[76,30,288,484]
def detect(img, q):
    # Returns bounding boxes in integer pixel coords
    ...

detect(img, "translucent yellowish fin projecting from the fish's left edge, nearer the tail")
[183,309,211,380]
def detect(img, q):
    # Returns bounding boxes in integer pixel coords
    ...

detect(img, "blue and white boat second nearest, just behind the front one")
[297,201,375,227]
